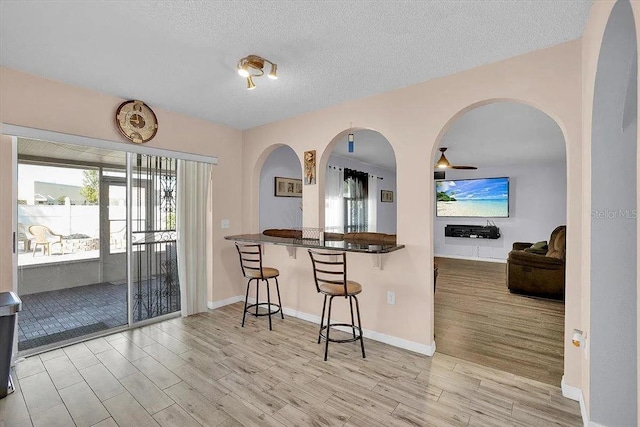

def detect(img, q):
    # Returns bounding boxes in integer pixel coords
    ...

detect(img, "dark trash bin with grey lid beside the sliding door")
[0,292,22,399]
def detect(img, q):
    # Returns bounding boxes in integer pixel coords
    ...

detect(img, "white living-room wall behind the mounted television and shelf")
[431,162,567,260]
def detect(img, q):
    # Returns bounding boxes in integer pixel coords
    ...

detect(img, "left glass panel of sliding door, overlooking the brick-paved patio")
[16,138,128,351]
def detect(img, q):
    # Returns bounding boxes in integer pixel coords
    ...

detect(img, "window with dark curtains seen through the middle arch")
[344,168,369,233]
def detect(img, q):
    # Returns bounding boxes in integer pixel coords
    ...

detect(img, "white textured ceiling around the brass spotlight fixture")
[0,0,591,129]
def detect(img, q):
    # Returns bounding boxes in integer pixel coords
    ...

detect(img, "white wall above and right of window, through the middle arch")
[329,155,398,234]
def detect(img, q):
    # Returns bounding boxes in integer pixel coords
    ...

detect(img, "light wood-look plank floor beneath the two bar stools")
[0,299,581,427]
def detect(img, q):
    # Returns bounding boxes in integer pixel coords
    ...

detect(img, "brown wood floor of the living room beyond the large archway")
[434,258,564,386]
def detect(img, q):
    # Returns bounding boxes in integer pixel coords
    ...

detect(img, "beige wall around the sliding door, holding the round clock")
[0,67,242,300]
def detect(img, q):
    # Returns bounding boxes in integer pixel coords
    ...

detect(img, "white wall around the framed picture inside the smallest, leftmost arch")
[260,146,302,231]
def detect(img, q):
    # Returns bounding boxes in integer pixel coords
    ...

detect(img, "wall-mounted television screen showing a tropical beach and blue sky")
[436,177,509,218]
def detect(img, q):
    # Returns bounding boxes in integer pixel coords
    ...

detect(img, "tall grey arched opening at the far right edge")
[587,0,638,425]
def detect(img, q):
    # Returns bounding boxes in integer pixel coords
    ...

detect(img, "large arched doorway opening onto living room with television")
[433,100,567,386]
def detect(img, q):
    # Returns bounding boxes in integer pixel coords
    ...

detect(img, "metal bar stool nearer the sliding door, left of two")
[236,243,284,331]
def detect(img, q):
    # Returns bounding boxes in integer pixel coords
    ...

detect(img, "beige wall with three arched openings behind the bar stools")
[242,41,582,387]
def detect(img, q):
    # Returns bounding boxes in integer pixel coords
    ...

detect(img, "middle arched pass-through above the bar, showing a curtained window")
[324,129,397,234]
